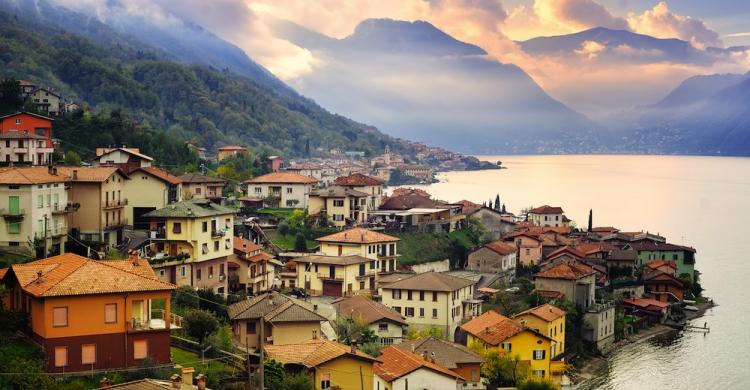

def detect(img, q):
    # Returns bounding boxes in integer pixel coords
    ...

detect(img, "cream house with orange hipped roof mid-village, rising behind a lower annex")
[315,227,400,276]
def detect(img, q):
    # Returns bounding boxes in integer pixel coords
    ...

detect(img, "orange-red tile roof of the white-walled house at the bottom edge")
[373,346,464,382]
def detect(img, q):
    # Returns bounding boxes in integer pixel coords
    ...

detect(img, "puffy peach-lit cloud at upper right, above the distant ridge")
[628,1,724,49]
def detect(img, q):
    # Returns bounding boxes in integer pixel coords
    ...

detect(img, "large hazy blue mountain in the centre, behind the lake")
[275,19,600,154]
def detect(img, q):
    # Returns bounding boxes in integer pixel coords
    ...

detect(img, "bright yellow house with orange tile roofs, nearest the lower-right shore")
[461,310,561,379]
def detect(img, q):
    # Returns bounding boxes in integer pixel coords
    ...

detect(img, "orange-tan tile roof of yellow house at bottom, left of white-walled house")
[264,339,378,368]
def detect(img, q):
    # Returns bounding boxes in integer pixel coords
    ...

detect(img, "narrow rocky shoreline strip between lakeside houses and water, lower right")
[574,299,718,385]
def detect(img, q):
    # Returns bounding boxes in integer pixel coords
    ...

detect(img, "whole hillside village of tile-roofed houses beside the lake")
[0,112,712,390]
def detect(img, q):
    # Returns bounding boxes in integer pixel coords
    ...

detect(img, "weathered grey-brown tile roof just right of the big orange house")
[227,292,326,322]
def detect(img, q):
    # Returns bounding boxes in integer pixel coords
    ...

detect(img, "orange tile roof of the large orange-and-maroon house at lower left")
[9,253,176,297]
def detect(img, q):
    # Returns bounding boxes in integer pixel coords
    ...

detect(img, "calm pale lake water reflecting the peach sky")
[394,156,750,389]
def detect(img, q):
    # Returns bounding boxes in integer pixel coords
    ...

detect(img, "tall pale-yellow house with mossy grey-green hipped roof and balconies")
[144,199,234,294]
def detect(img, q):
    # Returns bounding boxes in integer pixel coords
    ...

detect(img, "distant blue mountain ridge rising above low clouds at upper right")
[516,27,747,64]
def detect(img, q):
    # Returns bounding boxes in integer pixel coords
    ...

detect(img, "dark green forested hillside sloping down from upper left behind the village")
[0,12,403,156]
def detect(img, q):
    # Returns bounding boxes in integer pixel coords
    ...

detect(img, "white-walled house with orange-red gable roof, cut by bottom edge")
[373,346,465,390]
